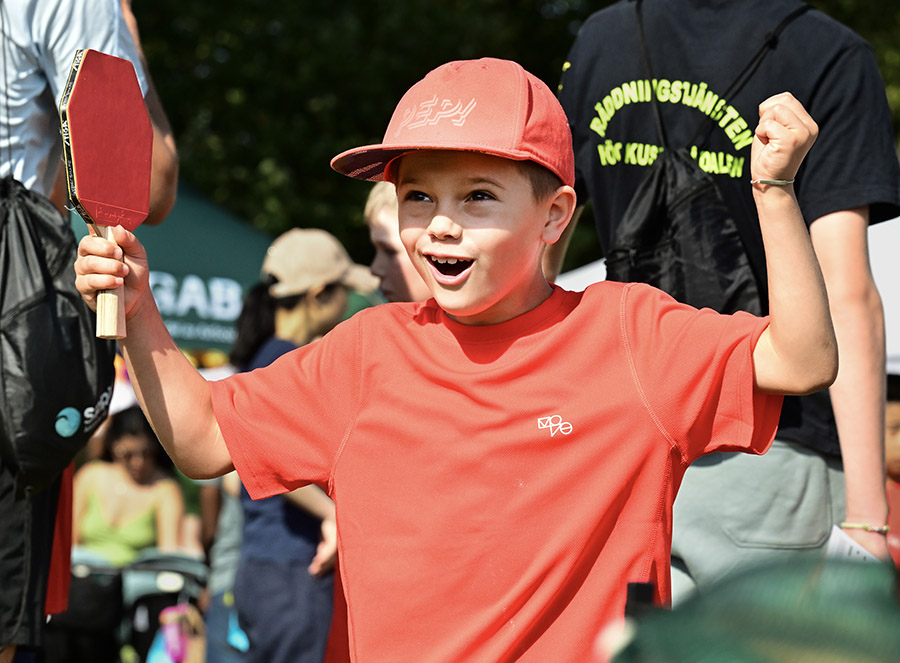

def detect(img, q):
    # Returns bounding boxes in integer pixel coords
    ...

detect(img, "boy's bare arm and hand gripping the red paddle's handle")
[75,226,233,479]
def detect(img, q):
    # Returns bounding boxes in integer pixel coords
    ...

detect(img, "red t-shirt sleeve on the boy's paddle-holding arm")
[210,315,363,499]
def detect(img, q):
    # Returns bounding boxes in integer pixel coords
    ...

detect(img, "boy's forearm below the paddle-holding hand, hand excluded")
[120,293,232,479]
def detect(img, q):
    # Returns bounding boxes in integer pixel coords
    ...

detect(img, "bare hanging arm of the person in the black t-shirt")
[810,207,888,558]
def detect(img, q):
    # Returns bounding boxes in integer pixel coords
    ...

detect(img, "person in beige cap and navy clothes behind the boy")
[230,228,378,663]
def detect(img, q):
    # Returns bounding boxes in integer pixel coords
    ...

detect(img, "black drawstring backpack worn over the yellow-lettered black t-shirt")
[606,0,810,315]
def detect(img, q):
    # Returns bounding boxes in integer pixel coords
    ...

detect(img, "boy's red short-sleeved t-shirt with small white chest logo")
[212,283,781,663]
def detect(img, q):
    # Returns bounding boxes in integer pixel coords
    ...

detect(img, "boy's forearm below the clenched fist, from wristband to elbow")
[753,184,837,394]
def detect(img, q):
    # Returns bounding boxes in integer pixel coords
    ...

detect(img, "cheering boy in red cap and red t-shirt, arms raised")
[76,59,837,663]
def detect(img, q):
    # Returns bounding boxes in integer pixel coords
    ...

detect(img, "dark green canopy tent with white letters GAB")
[72,183,272,354]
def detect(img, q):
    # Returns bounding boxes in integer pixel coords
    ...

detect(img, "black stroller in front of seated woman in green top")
[45,547,208,663]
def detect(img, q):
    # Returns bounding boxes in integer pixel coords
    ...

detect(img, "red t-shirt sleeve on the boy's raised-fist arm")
[622,284,782,463]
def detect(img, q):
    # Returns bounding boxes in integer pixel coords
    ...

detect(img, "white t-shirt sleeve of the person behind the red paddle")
[35,0,147,105]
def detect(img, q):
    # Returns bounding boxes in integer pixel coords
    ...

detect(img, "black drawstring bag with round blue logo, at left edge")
[0,177,115,491]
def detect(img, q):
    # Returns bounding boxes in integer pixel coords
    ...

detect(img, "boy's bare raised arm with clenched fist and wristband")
[750,93,837,394]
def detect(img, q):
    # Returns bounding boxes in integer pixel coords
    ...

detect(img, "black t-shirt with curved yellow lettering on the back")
[559,0,900,455]
